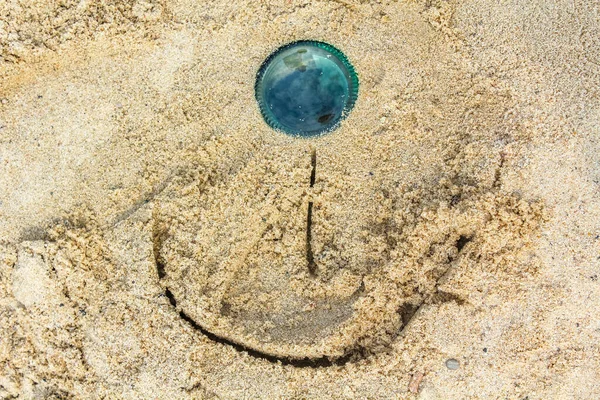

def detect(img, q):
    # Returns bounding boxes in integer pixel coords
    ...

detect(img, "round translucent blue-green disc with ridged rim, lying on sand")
[255,41,359,137]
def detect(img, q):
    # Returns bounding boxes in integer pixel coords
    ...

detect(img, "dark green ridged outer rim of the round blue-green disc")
[254,40,360,137]
